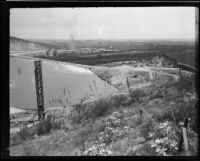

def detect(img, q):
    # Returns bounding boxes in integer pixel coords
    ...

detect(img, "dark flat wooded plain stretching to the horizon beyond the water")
[34,41,196,67]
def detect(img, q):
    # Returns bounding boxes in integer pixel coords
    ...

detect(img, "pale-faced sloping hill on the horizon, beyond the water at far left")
[10,36,63,51]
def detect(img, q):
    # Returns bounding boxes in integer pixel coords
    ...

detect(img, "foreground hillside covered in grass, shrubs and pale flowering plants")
[10,73,198,156]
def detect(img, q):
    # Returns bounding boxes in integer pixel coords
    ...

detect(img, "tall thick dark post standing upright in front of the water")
[34,59,45,121]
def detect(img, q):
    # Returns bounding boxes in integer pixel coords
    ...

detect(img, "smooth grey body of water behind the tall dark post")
[10,56,118,109]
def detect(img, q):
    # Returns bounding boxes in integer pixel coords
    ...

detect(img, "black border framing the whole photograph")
[1,0,200,160]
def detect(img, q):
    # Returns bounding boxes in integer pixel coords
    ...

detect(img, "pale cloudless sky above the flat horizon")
[10,7,195,40]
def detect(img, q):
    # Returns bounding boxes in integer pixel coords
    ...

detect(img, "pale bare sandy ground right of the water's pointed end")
[91,65,182,92]
